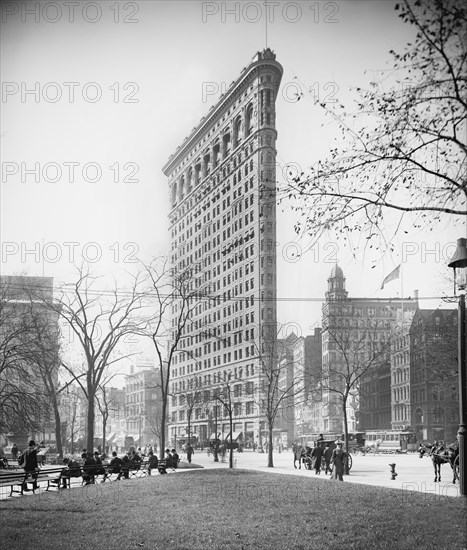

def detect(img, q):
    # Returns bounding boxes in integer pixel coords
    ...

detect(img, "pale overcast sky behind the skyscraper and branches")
[0,0,465,344]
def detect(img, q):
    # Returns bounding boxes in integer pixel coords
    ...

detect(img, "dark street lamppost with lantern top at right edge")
[448,239,467,496]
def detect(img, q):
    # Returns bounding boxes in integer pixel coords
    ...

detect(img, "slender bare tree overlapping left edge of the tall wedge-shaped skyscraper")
[146,258,200,458]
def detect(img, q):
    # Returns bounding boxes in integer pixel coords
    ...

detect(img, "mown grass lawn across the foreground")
[0,469,467,550]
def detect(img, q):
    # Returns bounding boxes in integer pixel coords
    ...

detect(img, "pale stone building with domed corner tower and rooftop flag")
[321,265,417,433]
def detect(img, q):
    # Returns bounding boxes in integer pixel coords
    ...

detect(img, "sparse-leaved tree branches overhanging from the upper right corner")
[283,0,467,254]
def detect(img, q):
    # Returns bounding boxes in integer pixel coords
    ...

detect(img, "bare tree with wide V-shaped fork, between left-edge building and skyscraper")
[47,267,148,449]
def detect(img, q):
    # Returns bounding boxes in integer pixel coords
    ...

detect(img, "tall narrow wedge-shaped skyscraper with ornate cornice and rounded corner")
[164,49,282,450]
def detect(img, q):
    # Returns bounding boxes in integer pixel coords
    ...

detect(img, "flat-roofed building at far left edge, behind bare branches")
[0,276,59,449]
